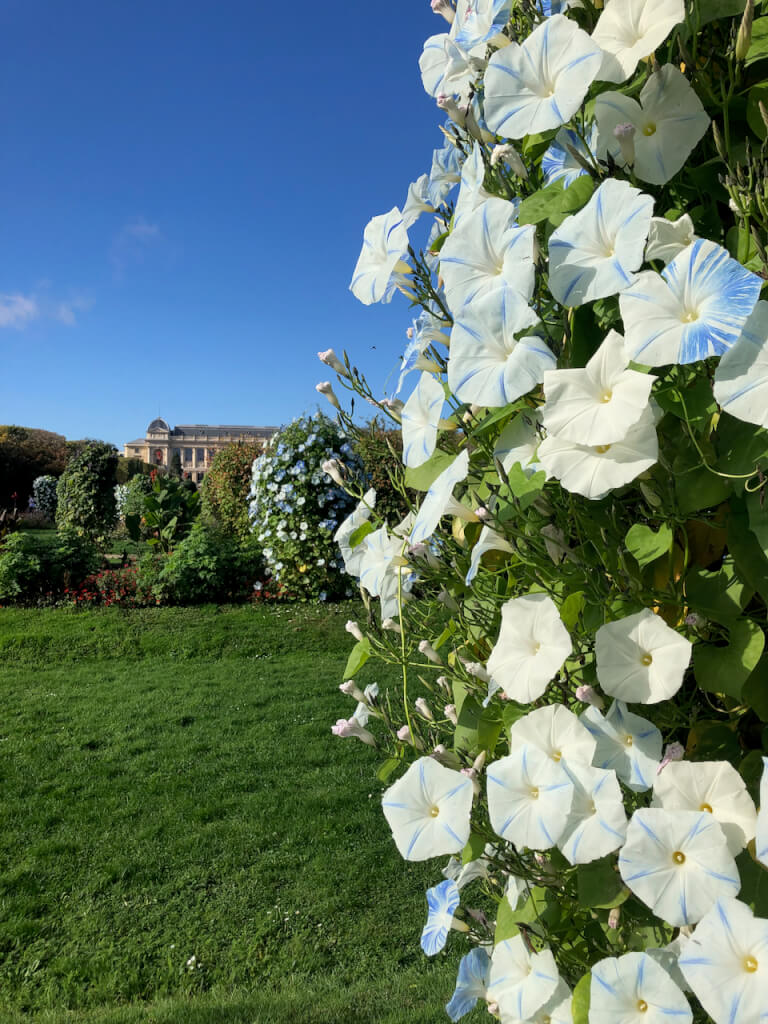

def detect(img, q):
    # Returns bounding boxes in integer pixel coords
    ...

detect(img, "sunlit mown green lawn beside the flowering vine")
[0,606,487,1024]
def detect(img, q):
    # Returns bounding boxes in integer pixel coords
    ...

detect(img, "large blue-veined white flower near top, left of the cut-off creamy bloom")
[483,14,602,138]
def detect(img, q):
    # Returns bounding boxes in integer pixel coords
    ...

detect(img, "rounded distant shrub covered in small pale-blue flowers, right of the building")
[249,413,360,600]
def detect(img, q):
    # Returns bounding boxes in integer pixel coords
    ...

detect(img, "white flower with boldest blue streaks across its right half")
[618,239,762,367]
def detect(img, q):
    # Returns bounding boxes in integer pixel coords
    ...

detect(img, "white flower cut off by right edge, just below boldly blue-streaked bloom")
[714,301,768,427]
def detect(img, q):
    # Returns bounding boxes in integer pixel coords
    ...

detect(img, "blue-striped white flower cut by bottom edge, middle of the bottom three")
[589,953,693,1024]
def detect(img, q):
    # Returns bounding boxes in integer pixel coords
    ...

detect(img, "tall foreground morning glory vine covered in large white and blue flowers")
[321,0,768,1024]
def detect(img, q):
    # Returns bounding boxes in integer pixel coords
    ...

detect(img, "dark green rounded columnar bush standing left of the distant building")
[56,441,118,539]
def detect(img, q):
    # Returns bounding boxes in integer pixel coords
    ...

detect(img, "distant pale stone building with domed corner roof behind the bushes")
[123,419,278,483]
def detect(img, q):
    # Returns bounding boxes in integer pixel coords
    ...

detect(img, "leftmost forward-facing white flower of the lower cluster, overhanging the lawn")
[382,758,474,860]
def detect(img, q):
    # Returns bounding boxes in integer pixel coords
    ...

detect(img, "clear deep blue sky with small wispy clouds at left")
[0,0,445,444]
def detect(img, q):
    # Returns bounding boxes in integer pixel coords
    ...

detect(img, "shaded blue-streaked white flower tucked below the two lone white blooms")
[581,700,662,793]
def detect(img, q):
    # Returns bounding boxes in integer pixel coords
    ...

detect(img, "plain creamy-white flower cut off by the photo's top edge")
[592,0,685,82]
